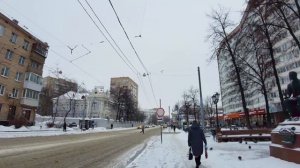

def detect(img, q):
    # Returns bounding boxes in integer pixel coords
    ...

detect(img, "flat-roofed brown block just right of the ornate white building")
[110,77,138,103]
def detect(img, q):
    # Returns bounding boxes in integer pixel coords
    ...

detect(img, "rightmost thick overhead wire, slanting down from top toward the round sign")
[108,0,158,105]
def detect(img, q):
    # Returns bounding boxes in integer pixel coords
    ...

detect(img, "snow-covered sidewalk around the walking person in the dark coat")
[126,129,300,168]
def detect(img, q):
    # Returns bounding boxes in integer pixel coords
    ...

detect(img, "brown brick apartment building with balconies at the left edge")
[0,13,49,124]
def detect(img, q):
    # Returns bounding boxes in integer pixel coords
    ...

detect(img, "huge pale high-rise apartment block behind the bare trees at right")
[218,0,300,122]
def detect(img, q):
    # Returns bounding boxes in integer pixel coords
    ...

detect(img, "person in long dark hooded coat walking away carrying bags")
[188,121,207,168]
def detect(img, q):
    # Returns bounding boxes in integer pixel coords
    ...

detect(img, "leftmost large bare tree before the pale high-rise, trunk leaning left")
[209,9,251,129]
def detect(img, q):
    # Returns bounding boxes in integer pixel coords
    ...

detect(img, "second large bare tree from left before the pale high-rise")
[238,22,272,126]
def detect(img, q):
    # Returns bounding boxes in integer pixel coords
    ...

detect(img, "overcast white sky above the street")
[0,0,245,111]
